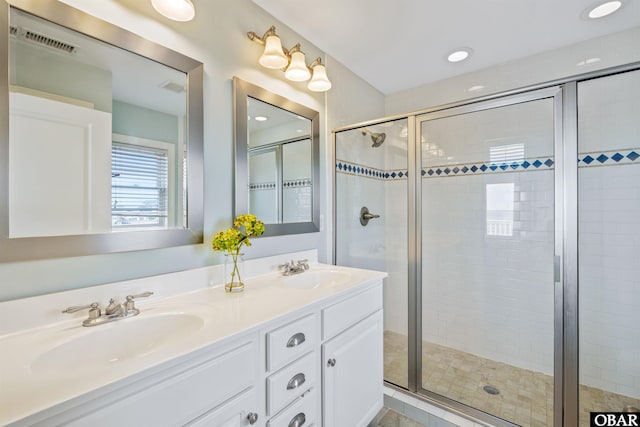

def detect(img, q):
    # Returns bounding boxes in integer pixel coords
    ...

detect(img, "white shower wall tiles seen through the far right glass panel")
[578,71,640,399]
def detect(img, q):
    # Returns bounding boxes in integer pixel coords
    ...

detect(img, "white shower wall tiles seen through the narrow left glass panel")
[336,119,408,335]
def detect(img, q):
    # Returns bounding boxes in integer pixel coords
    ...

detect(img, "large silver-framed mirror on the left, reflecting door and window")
[0,0,203,262]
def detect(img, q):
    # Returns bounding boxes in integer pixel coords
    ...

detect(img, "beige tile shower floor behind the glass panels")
[385,331,640,427]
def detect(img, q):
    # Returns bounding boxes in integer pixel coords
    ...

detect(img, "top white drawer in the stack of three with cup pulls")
[267,314,316,372]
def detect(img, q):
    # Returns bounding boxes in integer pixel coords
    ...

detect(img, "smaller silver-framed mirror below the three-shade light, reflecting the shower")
[233,77,320,236]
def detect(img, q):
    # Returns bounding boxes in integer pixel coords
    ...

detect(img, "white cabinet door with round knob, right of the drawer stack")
[322,311,383,427]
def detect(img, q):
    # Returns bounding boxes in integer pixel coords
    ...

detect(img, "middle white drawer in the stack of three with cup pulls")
[267,353,316,415]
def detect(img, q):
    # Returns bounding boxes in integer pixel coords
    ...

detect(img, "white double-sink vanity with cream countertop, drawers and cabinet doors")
[0,253,386,427]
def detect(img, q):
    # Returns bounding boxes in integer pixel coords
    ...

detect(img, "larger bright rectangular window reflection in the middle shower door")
[486,182,515,237]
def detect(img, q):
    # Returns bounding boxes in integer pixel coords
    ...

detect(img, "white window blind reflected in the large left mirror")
[111,142,169,228]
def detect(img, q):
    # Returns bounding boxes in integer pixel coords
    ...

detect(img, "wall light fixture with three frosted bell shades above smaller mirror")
[247,26,331,92]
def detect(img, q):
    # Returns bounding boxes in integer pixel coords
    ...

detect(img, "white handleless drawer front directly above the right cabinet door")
[322,283,382,340]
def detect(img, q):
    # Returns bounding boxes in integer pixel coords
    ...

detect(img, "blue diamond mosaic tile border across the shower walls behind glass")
[336,148,640,180]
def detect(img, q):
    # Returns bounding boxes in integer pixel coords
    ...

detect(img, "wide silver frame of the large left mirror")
[0,0,204,262]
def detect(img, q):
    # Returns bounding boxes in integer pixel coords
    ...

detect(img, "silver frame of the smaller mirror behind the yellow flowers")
[233,77,320,236]
